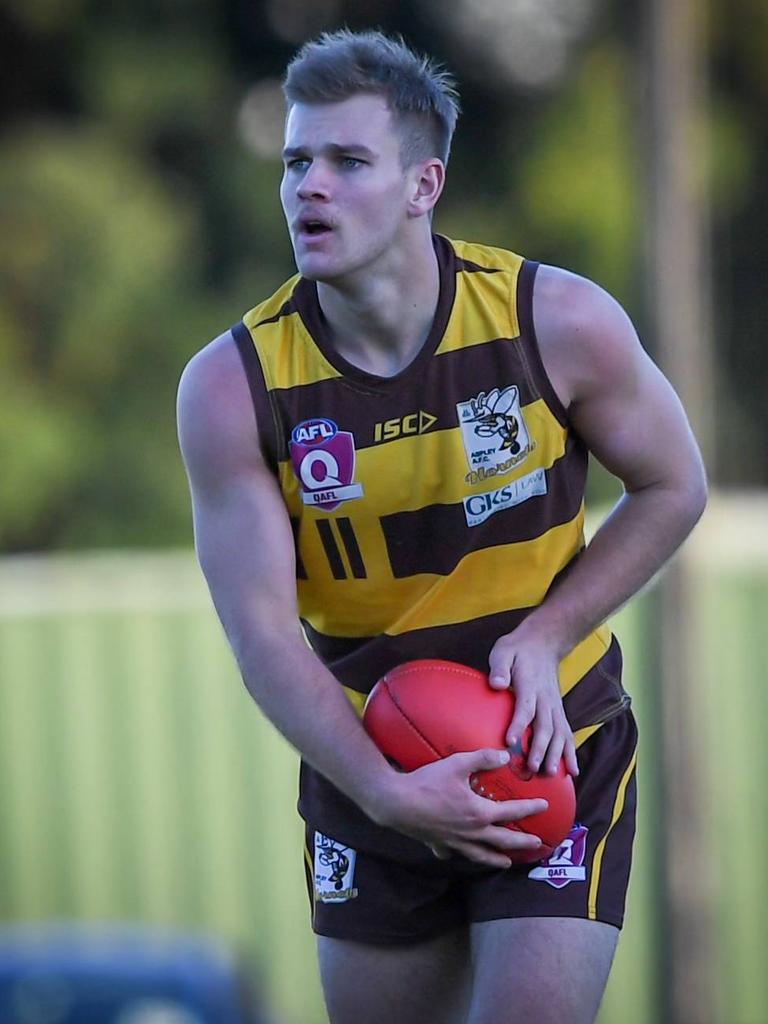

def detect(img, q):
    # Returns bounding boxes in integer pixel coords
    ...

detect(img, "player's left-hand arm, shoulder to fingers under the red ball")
[178,334,541,866]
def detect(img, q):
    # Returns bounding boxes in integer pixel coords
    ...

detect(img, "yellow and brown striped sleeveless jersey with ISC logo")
[232,236,629,848]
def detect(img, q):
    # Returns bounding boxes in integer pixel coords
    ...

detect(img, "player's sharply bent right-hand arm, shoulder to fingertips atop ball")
[490,267,707,771]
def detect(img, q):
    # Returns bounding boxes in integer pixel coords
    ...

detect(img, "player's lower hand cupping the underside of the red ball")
[368,750,548,867]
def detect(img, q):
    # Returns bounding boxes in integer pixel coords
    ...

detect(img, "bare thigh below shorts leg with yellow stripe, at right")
[467,918,618,1024]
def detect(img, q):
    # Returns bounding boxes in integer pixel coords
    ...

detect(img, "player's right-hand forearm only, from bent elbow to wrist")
[523,485,705,657]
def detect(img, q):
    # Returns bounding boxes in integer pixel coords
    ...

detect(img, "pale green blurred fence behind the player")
[0,497,768,1024]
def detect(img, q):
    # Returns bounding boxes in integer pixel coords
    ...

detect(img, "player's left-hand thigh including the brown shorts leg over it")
[306,826,470,1024]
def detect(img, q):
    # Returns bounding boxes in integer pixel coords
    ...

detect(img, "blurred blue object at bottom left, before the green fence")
[0,924,265,1024]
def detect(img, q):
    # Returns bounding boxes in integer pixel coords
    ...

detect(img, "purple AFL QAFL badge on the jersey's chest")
[289,417,362,512]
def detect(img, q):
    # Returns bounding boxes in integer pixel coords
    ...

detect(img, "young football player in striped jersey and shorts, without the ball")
[179,32,706,1024]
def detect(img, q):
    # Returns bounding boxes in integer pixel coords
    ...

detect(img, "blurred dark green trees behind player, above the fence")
[0,0,768,550]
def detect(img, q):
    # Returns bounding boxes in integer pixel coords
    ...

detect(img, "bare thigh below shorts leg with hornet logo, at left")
[317,928,473,1024]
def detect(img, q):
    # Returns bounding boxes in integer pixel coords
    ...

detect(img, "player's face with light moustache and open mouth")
[281,94,415,282]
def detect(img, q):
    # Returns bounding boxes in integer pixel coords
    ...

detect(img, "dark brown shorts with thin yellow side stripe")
[305,711,637,943]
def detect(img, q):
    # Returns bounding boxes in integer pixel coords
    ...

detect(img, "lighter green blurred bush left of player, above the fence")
[0,124,205,549]
